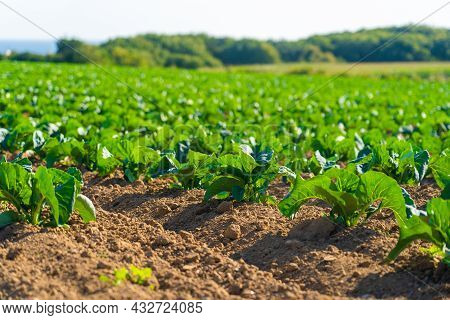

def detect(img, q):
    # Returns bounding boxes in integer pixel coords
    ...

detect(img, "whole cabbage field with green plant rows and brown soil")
[0,62,450,299]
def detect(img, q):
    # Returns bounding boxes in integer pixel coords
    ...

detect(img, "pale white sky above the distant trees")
[0,0,450,41]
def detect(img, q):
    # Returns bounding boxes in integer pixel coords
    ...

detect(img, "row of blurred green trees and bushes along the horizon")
[3,26,450,69]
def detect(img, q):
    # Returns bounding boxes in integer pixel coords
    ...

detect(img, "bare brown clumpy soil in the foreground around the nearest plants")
[0,173,450,299]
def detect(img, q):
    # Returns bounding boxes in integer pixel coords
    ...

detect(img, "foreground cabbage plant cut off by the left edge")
[0,162,96,227]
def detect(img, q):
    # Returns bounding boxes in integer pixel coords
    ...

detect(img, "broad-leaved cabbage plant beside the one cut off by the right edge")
[278,168,406,227]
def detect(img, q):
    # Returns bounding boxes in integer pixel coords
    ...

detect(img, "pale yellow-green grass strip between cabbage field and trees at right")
[207,62,450,79]
